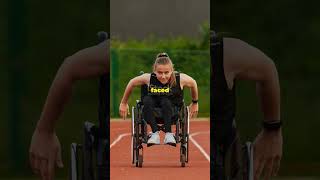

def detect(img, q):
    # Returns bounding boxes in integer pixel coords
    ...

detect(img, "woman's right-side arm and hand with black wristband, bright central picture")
[180,73,199,117]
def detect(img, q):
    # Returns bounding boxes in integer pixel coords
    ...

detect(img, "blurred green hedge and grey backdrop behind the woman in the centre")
[110,0,210,118]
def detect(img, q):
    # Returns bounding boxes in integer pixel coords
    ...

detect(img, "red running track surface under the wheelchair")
[110,120,210,180]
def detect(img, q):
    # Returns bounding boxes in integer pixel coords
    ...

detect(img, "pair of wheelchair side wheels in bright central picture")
[131,97,190,167]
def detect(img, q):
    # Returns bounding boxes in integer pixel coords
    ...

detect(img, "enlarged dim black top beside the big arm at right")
[210,34,236,144]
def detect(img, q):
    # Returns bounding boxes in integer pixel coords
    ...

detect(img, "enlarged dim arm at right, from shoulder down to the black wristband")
[224,38,280,121]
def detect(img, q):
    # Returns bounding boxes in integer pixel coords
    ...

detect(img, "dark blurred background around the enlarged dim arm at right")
[210,0,320,179]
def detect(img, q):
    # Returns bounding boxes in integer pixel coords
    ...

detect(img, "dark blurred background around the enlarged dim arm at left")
[0,0,109,179]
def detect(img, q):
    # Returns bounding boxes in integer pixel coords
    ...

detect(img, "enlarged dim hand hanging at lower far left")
[29,128,63,180]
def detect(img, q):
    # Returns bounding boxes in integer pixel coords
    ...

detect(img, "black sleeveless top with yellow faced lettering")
[148,73,183,106]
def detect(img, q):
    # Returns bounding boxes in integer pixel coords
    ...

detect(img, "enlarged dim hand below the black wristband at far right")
[253,129,283,180]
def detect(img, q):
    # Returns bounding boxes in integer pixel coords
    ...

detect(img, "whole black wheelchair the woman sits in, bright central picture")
[131,72,190,167]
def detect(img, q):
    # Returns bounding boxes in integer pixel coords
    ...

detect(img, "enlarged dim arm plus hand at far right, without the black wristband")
[224,38,282,179]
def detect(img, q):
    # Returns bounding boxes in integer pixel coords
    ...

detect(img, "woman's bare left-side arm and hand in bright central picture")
[119,73,150,119]
